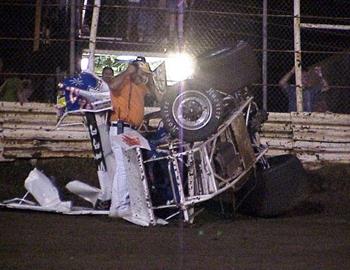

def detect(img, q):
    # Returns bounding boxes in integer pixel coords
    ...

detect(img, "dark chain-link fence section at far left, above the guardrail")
[0,1,69,102]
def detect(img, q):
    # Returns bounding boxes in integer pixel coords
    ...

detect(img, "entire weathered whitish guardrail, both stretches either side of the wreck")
[0,102,350,165]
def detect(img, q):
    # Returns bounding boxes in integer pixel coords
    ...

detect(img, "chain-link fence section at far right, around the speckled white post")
[268,0,350,113]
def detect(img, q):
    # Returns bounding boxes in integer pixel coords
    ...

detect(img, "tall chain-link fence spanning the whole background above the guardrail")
[0,0,350,113]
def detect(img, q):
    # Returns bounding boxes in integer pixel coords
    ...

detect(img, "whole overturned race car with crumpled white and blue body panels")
[2,42,306,226]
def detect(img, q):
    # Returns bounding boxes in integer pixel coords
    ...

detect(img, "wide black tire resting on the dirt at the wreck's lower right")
[238,155,307,217]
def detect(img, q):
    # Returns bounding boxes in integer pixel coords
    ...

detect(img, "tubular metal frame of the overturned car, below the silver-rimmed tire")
[139,99,267,223]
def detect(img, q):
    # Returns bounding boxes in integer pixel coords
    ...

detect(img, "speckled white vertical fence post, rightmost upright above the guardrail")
[294,0,303,112]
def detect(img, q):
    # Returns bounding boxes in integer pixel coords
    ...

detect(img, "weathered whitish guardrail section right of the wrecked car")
[261,112,350,164]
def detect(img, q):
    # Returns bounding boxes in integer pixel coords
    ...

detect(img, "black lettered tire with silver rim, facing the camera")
[161,82,223,142]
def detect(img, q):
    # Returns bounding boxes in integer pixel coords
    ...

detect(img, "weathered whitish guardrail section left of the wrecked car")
[0,102,93,161]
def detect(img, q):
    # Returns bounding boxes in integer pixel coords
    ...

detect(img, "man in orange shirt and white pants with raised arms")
[109,57,159,217]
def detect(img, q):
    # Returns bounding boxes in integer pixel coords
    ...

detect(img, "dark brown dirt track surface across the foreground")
[0,159,350,270]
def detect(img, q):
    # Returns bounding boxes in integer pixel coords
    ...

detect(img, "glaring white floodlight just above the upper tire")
[165,53,194,82]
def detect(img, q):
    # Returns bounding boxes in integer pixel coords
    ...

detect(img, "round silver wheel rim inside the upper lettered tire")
[172,90,213,130]
